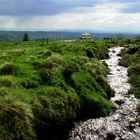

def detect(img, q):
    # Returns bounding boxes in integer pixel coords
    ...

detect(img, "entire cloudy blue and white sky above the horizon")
[0,0,140,33]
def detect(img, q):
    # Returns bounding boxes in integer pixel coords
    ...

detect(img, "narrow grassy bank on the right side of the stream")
[120,38,140,98]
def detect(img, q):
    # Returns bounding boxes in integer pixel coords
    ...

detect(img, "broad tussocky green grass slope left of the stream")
[0,40,113,140]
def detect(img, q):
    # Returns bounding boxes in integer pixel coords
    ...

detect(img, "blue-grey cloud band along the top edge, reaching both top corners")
[0,0,140,16]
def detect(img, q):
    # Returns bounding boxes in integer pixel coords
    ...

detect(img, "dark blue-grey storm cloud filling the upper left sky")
[0,0,100,16]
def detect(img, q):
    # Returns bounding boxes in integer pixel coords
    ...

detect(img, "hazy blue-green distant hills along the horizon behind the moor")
[0,31,137,42]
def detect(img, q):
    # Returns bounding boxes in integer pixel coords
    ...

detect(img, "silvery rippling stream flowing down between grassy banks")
[69,46,140,140]
